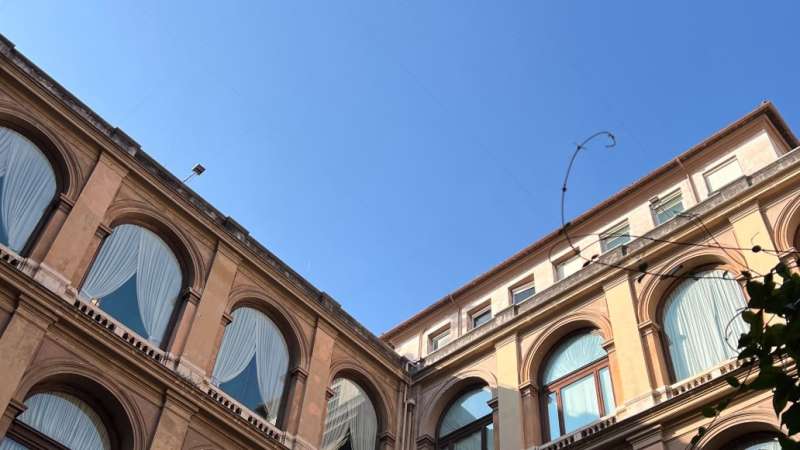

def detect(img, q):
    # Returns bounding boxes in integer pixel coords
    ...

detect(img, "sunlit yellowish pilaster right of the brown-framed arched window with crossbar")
[603,276,652,413]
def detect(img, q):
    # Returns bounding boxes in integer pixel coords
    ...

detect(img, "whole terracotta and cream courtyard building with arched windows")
[0,33,800,450]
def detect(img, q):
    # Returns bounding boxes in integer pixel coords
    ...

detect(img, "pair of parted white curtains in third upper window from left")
[212,308,289,423]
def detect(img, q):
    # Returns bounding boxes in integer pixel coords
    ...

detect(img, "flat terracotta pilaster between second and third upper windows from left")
[179,242,239,375]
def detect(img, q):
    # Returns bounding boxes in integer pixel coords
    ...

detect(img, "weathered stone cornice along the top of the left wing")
[0,34,404,372]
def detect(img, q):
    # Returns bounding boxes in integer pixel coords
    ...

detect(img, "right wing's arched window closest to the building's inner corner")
[437,386,494,450]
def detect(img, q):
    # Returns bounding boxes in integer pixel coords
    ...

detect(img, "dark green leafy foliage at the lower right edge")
[692,264,800,450]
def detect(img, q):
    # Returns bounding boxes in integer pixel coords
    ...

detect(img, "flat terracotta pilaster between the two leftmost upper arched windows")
[36,153,128,292]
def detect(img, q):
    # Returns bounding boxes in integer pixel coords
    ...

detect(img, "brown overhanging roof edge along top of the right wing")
[380,100,800,340]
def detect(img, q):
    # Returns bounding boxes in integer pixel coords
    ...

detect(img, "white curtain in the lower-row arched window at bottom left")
[17,392,111,450]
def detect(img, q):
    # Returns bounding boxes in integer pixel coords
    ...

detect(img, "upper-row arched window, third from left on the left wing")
[212,307,289,424]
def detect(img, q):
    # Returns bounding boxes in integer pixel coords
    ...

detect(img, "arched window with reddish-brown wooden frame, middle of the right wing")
[542,330,615,440]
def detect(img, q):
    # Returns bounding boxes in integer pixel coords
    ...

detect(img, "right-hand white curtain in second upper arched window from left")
[136,228,183,345]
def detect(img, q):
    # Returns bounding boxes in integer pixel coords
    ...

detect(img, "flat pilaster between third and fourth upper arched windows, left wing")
[296,318,338,448]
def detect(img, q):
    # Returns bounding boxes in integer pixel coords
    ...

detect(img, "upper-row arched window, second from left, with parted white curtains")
[81,224,183,346]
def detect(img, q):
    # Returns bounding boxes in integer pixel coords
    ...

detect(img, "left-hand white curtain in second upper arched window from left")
[81,224,141,298]
